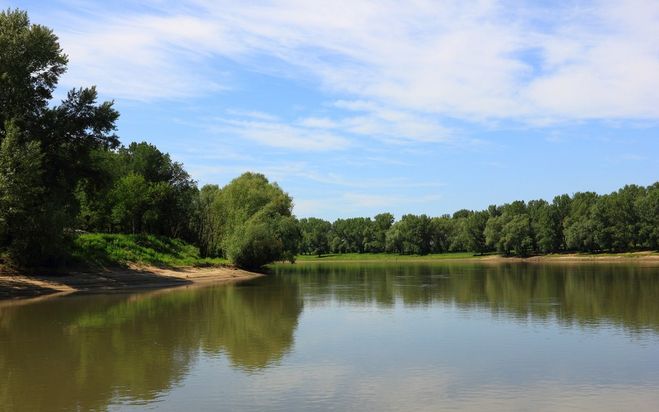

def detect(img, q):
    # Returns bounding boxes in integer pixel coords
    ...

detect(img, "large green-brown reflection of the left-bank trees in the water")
[0,285,302,411]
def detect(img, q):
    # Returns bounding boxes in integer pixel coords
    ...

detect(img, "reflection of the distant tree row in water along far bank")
[276,263,659,332]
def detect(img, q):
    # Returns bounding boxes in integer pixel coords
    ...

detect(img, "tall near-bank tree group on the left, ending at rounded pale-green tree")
[0,10,299,267]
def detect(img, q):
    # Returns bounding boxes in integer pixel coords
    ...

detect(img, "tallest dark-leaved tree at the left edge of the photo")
[0,10,119,265]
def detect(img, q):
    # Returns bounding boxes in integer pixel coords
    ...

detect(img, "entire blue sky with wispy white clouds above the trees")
[9,0,659,219]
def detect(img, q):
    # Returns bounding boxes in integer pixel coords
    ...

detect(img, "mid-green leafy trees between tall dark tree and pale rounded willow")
[76,142,198,240]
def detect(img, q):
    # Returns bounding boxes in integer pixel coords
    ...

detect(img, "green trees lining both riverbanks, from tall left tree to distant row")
[0,10,659,268]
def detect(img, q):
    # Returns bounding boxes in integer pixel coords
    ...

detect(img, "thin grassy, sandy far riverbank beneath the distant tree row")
[297,252,659,265]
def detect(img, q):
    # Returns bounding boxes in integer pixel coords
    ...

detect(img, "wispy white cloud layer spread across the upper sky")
[52,0,659,122]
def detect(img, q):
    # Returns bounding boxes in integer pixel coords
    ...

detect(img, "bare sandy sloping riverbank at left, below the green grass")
[0,265,263,300]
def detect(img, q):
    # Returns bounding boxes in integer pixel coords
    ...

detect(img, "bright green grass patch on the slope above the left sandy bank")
[72,233,228,267]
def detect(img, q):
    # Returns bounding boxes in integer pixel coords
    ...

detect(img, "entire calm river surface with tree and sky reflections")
[0,263,659,411]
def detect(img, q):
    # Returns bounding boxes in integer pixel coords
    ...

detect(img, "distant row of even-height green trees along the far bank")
[300,182,659,256]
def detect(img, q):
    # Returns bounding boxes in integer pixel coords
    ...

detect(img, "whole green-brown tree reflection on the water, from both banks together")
[0,263,659,411]
